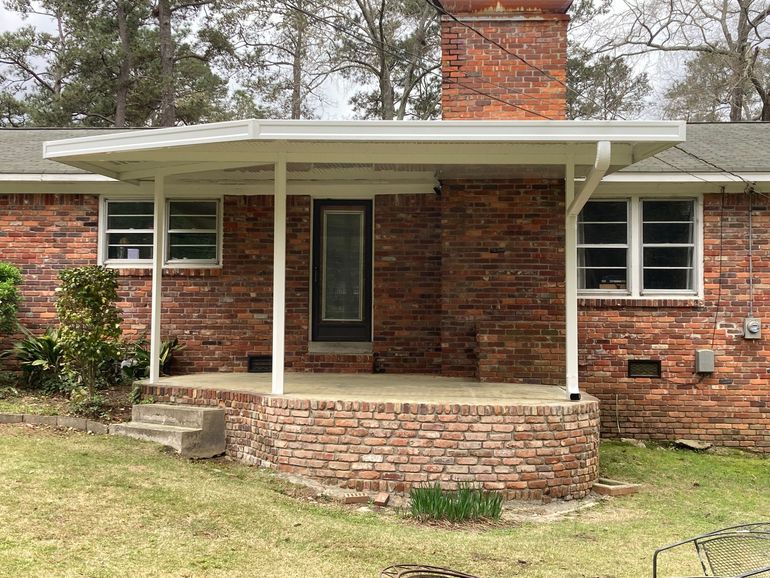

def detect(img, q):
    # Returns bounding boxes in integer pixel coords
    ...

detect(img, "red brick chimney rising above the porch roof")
[441,0,572,120]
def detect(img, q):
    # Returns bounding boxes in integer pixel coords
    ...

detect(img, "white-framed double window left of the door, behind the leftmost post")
[102,199,221,266]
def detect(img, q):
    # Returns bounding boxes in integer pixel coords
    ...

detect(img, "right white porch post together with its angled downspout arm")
[564,141,612,401]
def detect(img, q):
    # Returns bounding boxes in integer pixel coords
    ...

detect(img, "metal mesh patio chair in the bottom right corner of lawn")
[652,522,770,578]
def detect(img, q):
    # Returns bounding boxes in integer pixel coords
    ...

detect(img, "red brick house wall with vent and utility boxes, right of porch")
[580,195,770,451]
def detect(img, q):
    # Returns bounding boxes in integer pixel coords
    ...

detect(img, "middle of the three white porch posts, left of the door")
[272,155,286,395]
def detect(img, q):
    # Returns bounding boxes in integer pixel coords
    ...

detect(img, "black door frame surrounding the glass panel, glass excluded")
[310,199,374,342]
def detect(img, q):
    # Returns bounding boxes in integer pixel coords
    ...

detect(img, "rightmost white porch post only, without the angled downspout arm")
[564,158,580,401]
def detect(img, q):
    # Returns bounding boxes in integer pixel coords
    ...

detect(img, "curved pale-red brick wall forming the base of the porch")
[145,386,599,500]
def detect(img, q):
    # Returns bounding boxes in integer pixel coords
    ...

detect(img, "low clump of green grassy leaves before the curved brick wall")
[409,483,503,522]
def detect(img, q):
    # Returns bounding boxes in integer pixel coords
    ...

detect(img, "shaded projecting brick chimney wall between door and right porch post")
[441,179,565,383]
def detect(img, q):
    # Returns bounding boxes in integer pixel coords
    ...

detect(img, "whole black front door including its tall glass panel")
[312,200,372,341]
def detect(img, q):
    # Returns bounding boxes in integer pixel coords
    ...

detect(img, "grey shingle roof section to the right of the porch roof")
[622,122,770,173]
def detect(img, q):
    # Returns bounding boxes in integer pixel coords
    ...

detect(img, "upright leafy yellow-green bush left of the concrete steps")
[56,266,121,399]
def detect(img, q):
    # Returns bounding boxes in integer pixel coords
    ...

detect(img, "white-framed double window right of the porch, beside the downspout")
[577,197,700,297]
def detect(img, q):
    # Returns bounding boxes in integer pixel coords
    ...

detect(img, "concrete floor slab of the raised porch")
[147,372,576,405]
